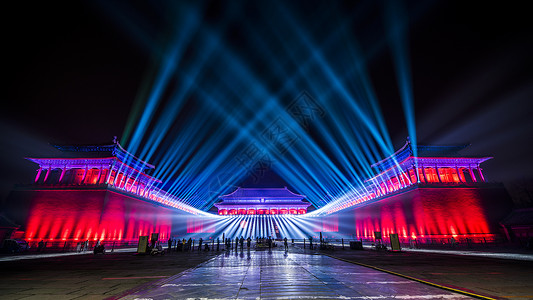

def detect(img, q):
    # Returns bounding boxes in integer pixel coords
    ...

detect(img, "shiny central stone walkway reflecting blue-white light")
[117,250,469,299]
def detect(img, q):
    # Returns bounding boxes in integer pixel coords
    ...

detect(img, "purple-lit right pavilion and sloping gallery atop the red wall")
[316,139,492,214]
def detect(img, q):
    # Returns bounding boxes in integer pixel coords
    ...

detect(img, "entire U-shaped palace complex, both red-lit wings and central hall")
[5,140,512,242]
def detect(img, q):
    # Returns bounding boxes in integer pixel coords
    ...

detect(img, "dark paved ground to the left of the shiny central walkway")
[0,247,216,299]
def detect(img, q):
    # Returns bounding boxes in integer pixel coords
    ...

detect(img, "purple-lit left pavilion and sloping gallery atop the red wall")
[26,141,194,213]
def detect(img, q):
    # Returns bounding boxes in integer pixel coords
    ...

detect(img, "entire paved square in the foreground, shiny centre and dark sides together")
[0,247,533,299]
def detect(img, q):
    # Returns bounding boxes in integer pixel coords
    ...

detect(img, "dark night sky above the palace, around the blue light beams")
[0,1,533,207]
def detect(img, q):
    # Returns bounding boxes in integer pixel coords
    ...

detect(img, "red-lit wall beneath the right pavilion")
[336,186,511,238]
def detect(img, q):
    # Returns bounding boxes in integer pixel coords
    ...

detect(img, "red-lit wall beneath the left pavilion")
[6,189,172,241]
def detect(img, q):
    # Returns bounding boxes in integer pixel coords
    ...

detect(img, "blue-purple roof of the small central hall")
[219,187,305,200]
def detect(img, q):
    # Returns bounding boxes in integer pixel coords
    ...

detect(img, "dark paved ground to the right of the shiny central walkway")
[324,250,533,299]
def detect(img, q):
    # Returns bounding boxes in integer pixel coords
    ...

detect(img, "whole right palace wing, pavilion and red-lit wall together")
[315,140,512,242]
